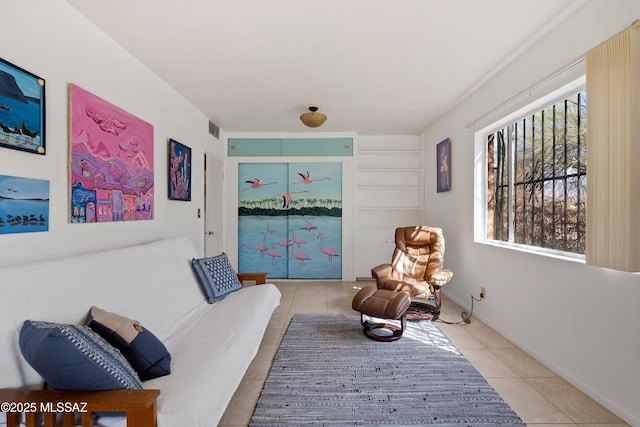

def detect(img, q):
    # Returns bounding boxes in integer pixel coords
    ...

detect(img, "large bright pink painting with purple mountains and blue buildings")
[69,84,154,222]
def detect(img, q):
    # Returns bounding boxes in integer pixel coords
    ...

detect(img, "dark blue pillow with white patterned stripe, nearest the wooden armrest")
[19,320,142,390]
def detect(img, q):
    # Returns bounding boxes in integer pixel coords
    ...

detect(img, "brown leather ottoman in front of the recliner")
[351,286,411,341]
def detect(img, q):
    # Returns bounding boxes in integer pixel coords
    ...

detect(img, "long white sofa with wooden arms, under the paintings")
[0,238,280,427]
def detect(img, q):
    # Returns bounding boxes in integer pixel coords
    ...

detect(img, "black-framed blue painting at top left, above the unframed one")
[0,59,45,154]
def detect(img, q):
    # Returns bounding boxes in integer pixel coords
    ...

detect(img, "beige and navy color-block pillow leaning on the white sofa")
[87,306,171,381]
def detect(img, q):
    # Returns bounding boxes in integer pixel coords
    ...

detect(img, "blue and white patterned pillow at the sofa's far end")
[191,252,242,304]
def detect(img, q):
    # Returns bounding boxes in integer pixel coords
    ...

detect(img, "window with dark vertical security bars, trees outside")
[483,85,587,254]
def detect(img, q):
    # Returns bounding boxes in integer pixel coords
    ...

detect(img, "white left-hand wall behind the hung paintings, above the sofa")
[0,0,224,266]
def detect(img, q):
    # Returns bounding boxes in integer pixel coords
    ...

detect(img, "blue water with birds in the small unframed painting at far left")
[0,199,49,234]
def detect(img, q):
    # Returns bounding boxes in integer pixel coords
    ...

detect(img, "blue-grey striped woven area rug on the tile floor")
[250,314,524,427]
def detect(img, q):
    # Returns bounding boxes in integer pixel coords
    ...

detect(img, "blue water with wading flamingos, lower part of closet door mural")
[238,215,342,279]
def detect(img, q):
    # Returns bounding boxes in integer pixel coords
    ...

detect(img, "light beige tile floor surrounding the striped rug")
[219,281,628,427]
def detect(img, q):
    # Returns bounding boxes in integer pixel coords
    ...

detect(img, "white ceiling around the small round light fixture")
[67,0,584,135]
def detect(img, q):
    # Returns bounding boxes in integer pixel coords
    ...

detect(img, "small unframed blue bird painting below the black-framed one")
[0,175,49,234]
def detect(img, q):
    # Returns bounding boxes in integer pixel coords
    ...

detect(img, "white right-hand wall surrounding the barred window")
[423,0,640,425]
